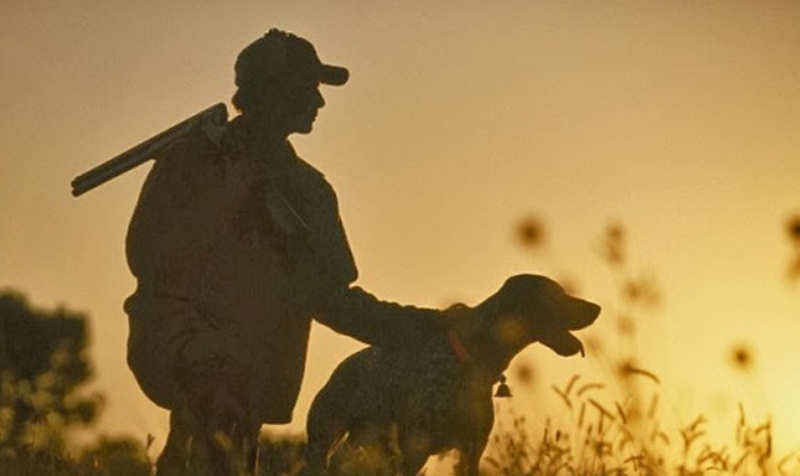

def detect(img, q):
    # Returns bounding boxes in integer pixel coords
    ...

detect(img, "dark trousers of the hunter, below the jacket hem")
[156,364,261,476]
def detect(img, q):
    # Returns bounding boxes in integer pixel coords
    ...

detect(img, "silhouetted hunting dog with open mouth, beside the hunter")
[303,275,600,476]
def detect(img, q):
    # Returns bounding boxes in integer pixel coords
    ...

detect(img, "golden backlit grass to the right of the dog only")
[484,372,800,476]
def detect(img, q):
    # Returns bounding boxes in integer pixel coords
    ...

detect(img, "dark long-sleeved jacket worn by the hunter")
[125,120,439,423]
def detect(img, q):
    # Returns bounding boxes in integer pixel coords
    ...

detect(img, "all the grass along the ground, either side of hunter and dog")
[0,384,800,476]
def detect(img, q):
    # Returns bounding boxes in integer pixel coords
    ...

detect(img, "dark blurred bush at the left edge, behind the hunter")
[0,292,101,450]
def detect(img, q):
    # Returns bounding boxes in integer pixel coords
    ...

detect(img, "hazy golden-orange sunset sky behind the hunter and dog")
[0,0,800,458]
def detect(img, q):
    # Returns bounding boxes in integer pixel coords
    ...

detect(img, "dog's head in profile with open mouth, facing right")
[476,274,600,356]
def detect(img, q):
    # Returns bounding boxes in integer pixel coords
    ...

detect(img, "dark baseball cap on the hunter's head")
[234,28,350,88]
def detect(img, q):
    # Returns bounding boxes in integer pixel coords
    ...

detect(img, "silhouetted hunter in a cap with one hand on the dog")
[125,29,450,476]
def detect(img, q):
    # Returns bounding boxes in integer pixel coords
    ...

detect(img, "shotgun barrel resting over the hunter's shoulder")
[71,103,228,197]
